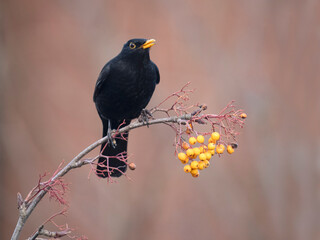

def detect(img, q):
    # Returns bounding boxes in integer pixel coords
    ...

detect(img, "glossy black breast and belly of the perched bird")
[98,62,156,119]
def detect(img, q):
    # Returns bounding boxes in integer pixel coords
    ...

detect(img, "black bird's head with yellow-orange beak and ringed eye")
[121,38,156,57]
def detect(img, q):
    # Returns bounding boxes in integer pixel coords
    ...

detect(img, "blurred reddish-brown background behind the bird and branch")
[0,0,320,240]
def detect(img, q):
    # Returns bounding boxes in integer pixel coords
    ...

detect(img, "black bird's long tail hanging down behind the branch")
[97,121,130,178]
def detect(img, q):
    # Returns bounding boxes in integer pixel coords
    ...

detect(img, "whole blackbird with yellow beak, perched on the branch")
[93,39,160,178]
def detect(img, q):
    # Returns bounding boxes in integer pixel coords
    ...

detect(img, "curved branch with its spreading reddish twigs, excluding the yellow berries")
[11,83,244,240]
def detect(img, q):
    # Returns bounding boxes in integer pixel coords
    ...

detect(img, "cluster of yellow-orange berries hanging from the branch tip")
[178,132,236,177]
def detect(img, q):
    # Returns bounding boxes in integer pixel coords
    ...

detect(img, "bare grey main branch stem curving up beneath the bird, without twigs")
[11,113,194,240]
